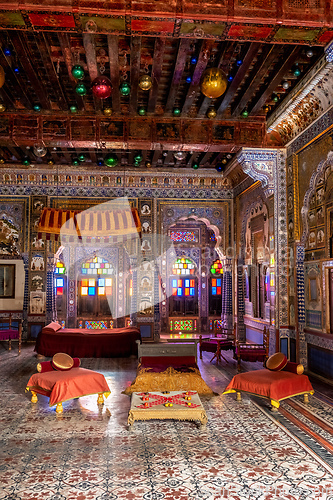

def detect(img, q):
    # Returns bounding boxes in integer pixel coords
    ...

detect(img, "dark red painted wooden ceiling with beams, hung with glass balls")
[0,0,333,177]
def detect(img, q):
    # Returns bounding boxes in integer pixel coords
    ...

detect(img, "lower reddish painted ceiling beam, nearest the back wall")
[0,113,266,152]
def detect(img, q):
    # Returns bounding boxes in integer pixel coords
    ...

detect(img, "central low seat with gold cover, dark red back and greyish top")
[124,342,213,395]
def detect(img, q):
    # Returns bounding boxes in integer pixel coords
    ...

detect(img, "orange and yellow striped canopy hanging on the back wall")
[38,204,141,243]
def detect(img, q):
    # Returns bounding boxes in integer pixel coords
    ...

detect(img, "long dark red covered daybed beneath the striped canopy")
[35,322,141,358]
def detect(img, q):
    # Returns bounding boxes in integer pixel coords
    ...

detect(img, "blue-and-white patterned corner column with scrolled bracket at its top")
[237,148,289,353]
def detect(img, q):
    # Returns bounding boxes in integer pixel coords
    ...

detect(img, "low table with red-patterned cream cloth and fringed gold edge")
[128,391,207,425]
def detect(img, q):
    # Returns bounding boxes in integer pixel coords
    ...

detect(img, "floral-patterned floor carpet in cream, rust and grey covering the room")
[0,346,333,500]
